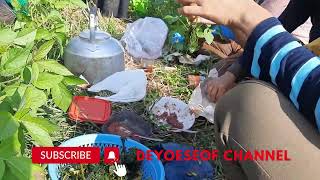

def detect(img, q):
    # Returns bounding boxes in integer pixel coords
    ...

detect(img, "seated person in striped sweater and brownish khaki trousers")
[178,0,320,180]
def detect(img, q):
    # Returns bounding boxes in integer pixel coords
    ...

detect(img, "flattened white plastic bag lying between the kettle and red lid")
[88,70,147,103]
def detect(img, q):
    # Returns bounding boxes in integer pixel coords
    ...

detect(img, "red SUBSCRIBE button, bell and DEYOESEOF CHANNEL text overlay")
[32,147,291,164]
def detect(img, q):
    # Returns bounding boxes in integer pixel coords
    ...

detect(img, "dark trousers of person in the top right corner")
[279,0,320,42]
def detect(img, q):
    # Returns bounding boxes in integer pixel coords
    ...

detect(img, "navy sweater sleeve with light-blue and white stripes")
[240,18,320,129]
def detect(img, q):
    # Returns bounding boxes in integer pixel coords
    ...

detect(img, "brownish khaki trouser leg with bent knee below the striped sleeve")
[215,81,320,180]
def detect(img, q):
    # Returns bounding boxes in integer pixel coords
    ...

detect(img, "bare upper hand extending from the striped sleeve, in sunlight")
[177,0,272,47]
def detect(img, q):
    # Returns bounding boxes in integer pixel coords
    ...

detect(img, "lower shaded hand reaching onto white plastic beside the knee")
[204,71,236,103]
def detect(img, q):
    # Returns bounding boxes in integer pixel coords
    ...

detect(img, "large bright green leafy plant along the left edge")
[0,0,86,180]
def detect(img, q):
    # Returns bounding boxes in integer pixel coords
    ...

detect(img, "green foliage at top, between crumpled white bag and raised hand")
[130,0,213,54]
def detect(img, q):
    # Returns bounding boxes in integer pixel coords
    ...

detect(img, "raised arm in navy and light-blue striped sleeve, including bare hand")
[179,0,320,128]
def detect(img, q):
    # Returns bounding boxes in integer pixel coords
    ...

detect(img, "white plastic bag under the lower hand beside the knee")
[189,69,218,123]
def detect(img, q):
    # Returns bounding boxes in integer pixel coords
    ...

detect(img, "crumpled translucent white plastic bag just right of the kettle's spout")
[121,17,168,60]
